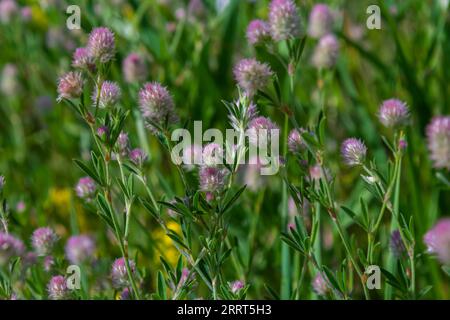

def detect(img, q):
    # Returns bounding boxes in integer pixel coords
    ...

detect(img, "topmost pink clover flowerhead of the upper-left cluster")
[87,27,115,63]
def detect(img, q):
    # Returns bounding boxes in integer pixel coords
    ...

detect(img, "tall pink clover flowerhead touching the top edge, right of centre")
[269,0,302,41]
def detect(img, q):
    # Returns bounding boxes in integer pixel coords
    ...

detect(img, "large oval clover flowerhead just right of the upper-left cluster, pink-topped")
[139,82,178,132]
